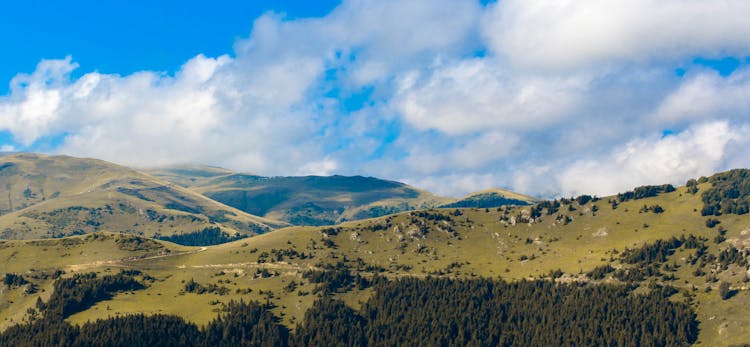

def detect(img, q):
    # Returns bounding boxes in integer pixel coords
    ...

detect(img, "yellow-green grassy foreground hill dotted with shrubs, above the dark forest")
[0,170,750,346]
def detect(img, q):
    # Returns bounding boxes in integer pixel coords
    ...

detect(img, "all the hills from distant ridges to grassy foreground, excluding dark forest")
[0,154,750,346]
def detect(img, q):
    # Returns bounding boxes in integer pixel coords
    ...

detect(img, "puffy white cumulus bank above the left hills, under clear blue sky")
[0,55,326,170]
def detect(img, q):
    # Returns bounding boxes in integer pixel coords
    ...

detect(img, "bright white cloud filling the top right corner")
[483,0,750,70]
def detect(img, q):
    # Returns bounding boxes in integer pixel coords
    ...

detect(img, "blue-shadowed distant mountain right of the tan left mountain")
[149,166,451,225]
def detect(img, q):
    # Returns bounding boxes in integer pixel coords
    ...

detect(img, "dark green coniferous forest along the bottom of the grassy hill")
[0,273,698,346]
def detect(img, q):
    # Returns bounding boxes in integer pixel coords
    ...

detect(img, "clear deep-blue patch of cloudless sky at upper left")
[0,0,340,93]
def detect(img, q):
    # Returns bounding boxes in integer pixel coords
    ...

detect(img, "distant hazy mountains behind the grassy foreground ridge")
[0,153,536,239]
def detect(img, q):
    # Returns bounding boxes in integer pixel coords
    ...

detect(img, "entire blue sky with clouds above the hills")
[0,0,750,197]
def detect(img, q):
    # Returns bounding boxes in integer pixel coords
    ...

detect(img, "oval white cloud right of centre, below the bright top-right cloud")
[395,58,588,135]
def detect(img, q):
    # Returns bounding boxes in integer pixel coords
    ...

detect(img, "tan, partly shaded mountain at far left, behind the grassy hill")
[0,153,286,239]
